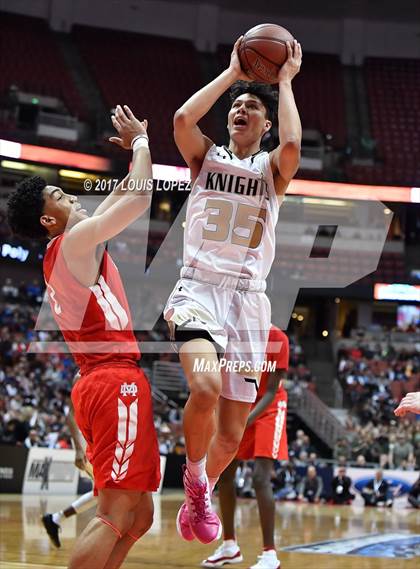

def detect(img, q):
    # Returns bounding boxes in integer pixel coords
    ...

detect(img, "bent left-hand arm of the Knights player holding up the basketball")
[174,37,249,179]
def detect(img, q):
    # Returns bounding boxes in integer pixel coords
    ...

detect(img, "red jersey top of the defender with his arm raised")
[44,234,140,374]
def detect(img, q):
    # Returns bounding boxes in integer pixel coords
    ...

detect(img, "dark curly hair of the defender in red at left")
[7,176,48,239]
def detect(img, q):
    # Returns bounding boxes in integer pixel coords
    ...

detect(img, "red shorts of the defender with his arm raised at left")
[71,364,160,494]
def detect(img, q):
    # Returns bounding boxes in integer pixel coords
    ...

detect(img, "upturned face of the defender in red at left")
[40,186,88,235]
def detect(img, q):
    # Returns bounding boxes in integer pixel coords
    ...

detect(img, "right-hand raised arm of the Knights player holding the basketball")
[270,40,302,195]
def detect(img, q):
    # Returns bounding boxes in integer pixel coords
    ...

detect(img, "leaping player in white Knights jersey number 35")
[164,38,302,543]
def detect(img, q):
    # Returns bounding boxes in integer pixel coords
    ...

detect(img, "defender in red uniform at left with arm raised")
[8,106,160,569]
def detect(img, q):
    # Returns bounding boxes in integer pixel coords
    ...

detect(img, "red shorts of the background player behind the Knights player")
[236,401,289,460]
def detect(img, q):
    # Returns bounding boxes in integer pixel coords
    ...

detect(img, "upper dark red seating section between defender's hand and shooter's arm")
[74,26,208,164]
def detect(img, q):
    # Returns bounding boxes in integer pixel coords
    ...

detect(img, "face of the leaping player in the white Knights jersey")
[228,93,271,145]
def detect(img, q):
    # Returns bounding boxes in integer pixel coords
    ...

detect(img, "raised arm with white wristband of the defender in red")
[63,106,153,257]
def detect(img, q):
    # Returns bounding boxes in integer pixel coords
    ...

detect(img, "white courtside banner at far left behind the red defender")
[23,448,79,494]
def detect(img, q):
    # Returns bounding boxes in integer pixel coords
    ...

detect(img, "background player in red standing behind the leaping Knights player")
[202,326,289,569]
